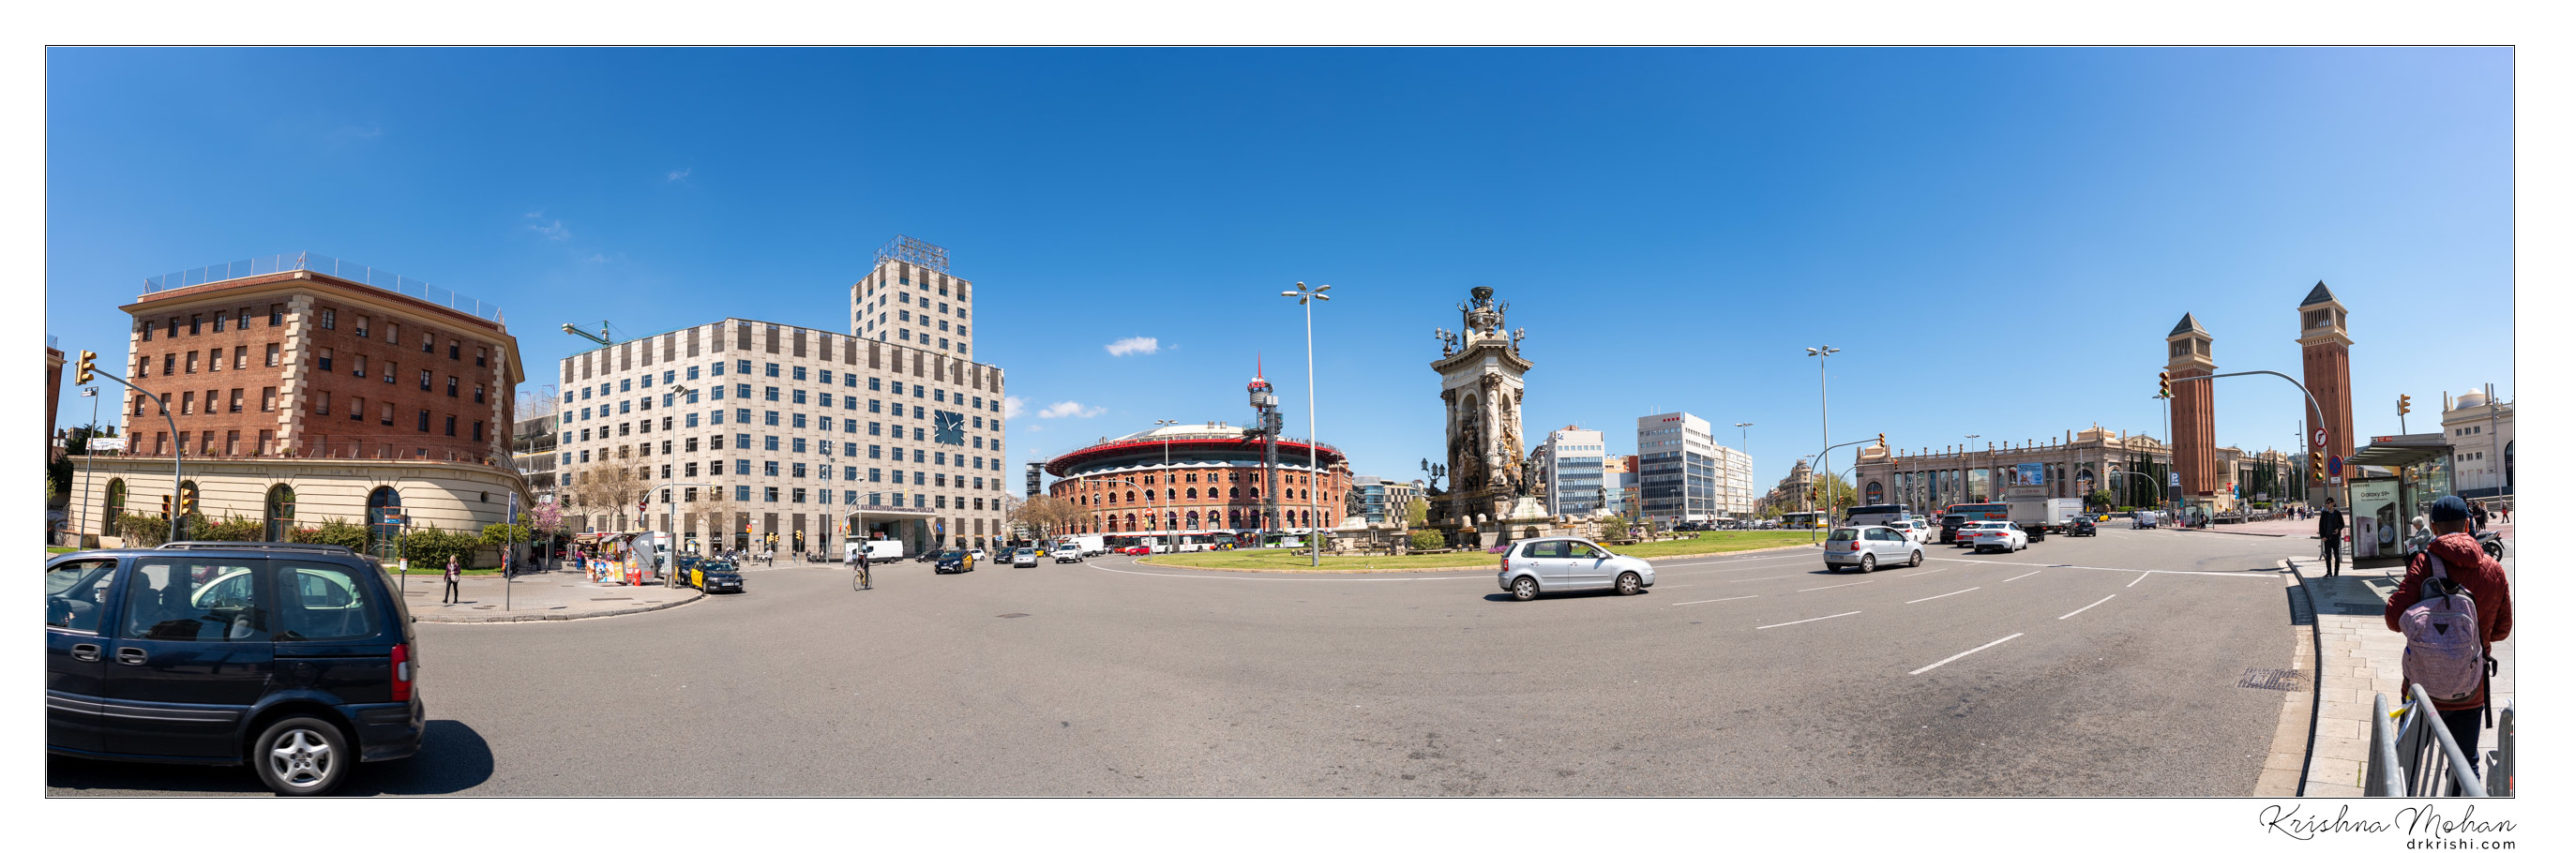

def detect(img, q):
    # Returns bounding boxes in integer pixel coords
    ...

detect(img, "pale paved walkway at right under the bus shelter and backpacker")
[2286,551,2516,797]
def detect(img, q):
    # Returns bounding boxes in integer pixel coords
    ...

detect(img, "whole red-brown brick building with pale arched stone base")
[79,256,525,555]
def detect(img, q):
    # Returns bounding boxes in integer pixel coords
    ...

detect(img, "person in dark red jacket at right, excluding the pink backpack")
[2383,494,2516,768]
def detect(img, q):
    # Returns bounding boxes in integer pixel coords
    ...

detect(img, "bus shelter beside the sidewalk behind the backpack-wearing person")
[2345,435,2452,569]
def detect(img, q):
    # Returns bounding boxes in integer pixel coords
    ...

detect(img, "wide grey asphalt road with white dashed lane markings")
[49,528,2304,797]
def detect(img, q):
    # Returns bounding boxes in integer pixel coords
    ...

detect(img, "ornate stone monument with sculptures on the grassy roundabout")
[1431,287,1556,548]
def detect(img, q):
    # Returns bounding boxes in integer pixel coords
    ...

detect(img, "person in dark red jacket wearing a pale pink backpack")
[2383,494,2516,766]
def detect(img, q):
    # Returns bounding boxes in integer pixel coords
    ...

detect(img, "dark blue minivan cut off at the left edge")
[44,543,428,797]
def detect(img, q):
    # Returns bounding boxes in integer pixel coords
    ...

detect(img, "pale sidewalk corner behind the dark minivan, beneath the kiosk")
[392,571,701,622]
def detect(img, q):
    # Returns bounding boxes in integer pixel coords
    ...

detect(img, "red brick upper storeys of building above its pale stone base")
[123,272,522,464]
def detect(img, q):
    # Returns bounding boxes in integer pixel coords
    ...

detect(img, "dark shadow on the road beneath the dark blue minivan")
[44,720,497,797]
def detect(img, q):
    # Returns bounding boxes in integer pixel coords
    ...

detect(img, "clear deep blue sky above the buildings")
[46,49,2516,489]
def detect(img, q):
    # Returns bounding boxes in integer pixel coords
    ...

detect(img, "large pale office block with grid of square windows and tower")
[558,238,1004,553]
